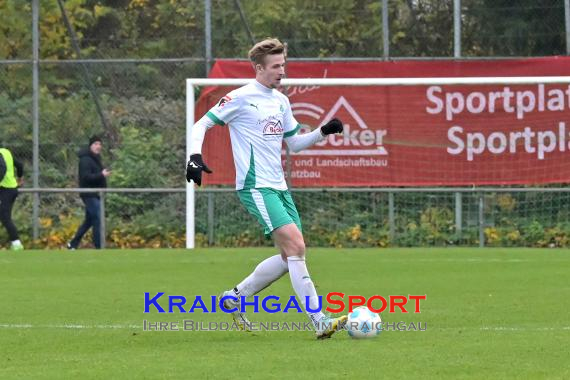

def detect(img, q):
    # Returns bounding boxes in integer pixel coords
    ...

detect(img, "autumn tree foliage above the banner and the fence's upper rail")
[0,0,564,59]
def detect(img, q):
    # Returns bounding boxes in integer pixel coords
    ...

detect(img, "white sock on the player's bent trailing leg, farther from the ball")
[234,255,289,297]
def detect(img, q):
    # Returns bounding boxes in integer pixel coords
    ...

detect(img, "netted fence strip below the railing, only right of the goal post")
[196,189,570,248]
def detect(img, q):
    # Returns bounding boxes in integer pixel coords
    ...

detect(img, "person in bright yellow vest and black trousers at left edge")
[0,148,24,251]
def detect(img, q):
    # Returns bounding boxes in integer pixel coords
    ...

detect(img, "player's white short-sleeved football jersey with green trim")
[206,81,301,190]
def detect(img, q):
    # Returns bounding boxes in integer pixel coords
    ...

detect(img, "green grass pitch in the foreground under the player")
[0,248,570,379]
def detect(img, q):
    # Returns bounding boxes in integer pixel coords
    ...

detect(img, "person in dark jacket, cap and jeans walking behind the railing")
[67,136,111,249]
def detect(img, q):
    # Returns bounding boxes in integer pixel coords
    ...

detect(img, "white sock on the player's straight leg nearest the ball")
[287,256,325,327]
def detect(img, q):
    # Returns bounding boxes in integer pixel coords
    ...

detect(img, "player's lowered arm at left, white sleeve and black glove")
[186,93,239,186]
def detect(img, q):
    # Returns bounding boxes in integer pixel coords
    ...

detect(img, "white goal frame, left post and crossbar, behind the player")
[186,76,570,249]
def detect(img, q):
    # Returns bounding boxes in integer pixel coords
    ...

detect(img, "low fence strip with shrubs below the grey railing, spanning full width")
[4,188,570,248]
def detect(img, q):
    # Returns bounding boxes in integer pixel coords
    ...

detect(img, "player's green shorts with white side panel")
[238,187,302,235]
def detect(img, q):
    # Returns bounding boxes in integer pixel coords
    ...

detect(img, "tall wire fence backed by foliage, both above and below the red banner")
[0,0,570,247]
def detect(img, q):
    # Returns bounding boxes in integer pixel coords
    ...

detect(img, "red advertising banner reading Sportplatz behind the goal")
[196,57,570,187]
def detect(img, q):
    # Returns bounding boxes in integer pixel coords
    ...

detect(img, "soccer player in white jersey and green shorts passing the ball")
[186,39,347,339]
